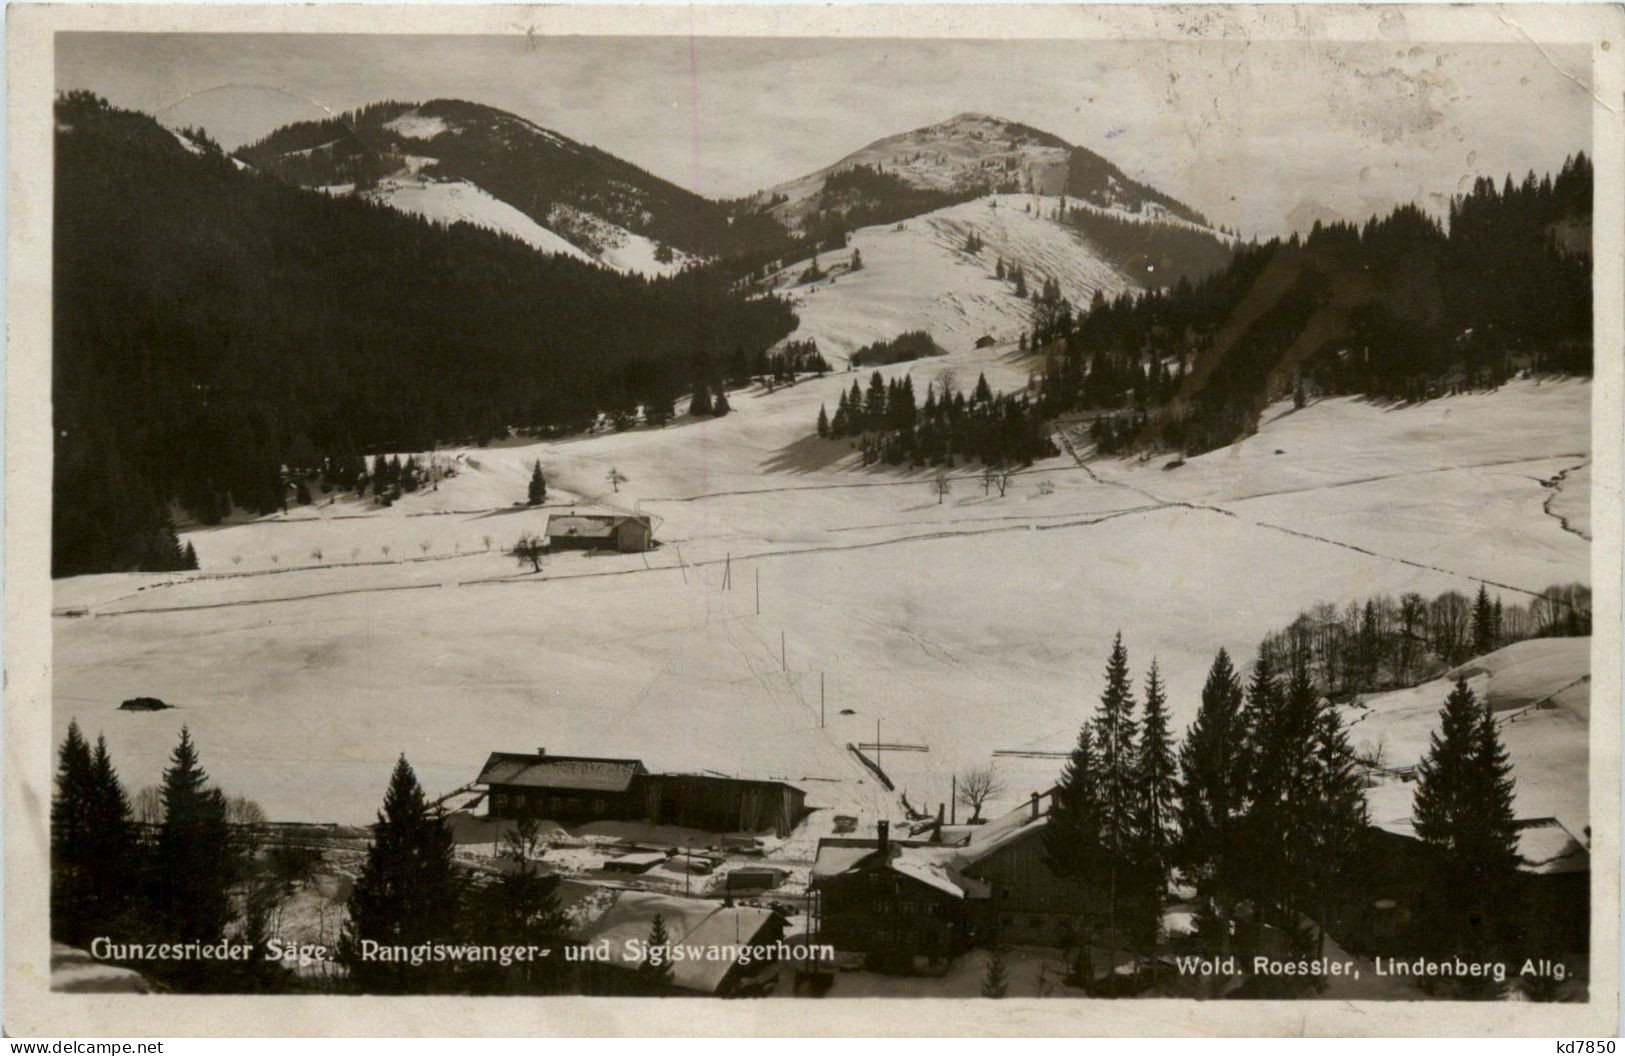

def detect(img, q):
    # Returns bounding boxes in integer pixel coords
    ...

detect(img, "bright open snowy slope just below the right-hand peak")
[775,195,1138,362]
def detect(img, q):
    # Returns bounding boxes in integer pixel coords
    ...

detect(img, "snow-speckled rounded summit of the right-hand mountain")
[754,114,1207,234]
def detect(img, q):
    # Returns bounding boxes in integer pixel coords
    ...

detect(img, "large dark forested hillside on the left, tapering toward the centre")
[52,93,795,575]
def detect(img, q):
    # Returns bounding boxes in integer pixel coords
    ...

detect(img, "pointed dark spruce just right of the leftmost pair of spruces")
[153,726,237,942]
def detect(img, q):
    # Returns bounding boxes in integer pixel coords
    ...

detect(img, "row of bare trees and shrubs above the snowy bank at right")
[1259,583,1591,699]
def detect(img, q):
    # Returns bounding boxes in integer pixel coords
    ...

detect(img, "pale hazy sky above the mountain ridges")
[57,34,1593,237]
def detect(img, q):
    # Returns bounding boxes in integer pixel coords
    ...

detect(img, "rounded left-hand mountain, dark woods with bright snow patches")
[237,99,754,275]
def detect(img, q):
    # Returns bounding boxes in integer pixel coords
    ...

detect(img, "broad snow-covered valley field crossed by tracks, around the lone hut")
[54,370,1591,822]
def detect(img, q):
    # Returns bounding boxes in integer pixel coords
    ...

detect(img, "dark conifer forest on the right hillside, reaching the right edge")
[1042,154,1593,453]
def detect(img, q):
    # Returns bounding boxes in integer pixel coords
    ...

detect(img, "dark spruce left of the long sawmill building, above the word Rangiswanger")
[338,755,462,993]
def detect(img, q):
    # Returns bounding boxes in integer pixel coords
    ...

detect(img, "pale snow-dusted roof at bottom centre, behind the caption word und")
[587,890,774,994]
